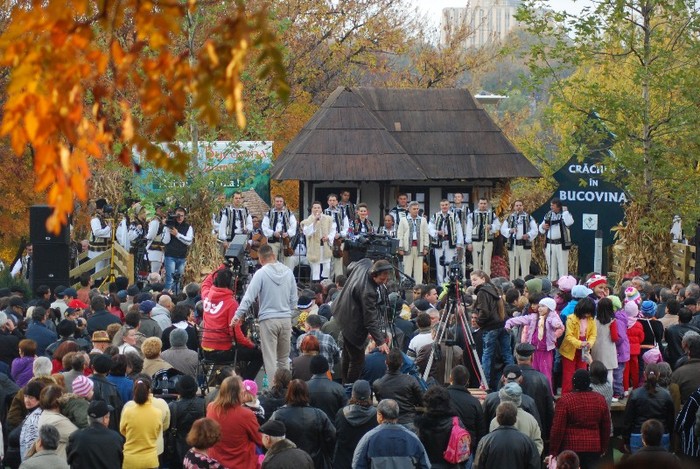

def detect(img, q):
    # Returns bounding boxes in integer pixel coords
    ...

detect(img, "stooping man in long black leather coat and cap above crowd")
[333,259,393,384]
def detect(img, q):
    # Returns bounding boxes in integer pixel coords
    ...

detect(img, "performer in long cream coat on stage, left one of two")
[301,202,337,282]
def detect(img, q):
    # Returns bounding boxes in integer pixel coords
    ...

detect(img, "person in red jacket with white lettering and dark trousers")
[202,265,263,380]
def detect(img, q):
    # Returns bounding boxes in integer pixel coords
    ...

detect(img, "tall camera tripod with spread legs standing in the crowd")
[423,279,488,390]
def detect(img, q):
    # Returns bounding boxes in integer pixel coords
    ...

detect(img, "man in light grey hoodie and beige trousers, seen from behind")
[231,245,298,376]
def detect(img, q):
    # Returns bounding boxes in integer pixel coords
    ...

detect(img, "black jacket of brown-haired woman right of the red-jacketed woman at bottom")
[270,405,335,469]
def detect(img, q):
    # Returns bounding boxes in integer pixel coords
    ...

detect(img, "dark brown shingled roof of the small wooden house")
[271,87,541,181]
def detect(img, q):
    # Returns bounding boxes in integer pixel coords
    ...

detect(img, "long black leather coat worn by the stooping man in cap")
[333,259,385,348]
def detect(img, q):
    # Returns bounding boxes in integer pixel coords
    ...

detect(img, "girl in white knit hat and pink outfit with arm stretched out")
[505,297,564,388]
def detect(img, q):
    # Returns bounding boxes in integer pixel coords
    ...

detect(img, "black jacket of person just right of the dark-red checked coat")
[622,386,675,444]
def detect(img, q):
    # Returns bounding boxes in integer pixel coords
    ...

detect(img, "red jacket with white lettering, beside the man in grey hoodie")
[202,266,255,350]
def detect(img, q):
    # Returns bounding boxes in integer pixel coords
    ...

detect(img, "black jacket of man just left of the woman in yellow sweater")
[66,423,124,469]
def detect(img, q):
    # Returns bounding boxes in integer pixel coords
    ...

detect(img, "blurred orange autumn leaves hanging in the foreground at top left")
[0,0,288,231]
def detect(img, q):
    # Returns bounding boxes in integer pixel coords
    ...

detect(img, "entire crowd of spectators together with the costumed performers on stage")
[0,188,700,469]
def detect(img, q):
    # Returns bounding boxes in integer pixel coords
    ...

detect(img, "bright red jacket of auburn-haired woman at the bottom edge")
[207,398,266,469]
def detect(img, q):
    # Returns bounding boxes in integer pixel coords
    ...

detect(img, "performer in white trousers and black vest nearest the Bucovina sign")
[540,197,574,282]
